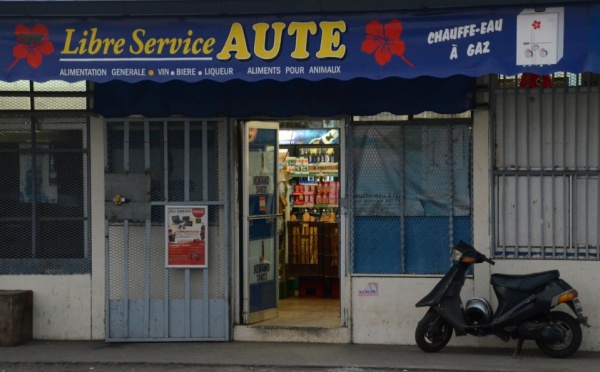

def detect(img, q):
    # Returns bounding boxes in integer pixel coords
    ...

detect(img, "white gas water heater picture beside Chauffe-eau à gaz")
[517,7,565,66]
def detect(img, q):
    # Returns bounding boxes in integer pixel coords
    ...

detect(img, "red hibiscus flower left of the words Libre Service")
[6,24,54,71]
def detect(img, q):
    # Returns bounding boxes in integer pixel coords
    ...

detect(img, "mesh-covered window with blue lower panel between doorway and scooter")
[348,119,472,274]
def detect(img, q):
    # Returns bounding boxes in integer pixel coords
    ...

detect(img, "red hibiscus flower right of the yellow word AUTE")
[360,19,414,67]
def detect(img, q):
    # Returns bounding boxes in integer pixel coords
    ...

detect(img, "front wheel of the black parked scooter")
[415,311,452,353]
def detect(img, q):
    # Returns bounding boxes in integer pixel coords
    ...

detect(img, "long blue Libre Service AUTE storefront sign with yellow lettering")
[0,4,600,82]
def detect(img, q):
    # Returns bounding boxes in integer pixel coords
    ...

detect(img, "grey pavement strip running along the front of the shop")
[0,341,600,372]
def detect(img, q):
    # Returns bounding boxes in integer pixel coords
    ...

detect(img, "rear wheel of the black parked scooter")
[535,311,582,358]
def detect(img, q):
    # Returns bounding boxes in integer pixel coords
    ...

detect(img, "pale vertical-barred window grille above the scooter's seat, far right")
[492,73,600,259]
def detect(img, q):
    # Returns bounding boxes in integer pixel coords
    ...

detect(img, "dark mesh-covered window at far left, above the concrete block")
[0,81,91,275]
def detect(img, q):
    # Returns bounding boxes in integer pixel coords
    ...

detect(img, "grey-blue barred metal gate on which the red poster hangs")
[105,119,230,341]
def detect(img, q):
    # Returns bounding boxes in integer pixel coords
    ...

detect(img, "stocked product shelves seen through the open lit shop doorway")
[279,144,340,298]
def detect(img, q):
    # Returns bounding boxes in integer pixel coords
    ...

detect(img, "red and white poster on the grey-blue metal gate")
[165,206,208,268]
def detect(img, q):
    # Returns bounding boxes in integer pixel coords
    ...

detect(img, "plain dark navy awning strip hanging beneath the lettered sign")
[94,75,475,117]
